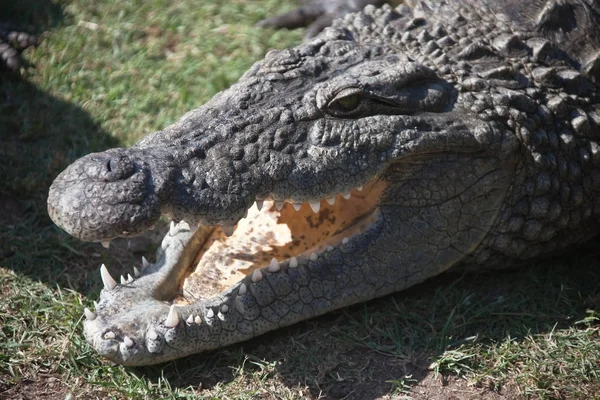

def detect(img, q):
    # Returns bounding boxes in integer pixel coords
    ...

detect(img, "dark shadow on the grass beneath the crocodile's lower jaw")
[132,240,600,400]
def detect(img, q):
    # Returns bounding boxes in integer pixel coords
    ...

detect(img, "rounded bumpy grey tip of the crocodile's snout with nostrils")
[48,149,166,242]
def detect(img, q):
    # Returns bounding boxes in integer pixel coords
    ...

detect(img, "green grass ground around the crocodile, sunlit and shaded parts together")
[0,0,600,399]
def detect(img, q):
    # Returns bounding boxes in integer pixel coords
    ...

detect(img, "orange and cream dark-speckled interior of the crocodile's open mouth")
[175,179,386,304]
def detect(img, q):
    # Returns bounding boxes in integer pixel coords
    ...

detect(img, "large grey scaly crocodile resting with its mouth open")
[48,0,600,365]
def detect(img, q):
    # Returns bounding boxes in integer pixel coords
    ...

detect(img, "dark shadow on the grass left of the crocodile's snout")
[0,0,118,289]
